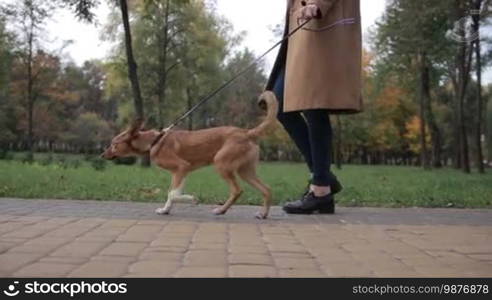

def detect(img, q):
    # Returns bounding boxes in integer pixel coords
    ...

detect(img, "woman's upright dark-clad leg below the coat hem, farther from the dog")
[303,109,336,196]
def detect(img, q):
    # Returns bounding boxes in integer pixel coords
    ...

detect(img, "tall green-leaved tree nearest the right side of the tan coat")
[375,0,450,168]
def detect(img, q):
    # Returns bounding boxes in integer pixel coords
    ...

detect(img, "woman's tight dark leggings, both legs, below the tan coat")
[273,71,335,186]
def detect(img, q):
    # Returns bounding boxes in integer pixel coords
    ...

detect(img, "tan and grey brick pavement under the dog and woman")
[0,198,492,277]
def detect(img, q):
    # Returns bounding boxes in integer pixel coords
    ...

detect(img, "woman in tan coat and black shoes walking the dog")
[266,0,362,214]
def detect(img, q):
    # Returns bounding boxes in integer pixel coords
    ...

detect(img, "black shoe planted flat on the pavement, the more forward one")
[283,193,335,215]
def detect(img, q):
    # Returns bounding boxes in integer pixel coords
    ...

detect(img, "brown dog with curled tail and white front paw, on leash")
[102,91,278,219]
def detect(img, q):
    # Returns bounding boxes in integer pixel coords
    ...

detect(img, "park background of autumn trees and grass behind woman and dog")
[0,0,492,207]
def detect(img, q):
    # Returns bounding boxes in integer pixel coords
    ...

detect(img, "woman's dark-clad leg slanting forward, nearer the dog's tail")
[273,71,313,173]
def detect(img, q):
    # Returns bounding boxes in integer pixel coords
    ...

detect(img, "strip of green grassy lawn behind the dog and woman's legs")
[0,157,492,208]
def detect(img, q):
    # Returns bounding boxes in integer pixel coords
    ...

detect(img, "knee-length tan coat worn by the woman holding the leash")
[267,0,362,113]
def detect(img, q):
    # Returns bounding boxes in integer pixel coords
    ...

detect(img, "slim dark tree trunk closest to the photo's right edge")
[472,0,485,174]
